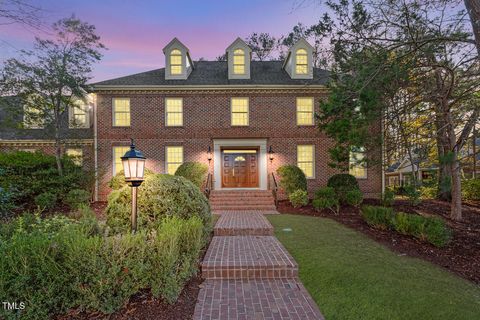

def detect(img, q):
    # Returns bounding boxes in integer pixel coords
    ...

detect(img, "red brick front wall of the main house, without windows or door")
[96,89,381,200]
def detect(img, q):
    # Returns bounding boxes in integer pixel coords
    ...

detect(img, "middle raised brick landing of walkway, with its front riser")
[201,236,298,279]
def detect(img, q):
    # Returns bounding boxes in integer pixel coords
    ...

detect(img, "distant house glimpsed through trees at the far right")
[385,157,438,187]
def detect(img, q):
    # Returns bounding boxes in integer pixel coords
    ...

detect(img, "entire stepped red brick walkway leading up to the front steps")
[193,200,323,320]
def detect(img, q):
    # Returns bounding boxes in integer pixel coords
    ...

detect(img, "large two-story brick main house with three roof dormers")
[93,38,382,200]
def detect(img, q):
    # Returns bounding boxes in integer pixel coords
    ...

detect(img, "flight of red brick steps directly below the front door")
[209,190,276,211]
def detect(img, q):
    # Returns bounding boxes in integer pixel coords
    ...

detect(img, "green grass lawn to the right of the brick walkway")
[267,215,480,320]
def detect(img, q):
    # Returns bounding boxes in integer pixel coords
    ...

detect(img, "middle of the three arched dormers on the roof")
[227,38,252,79]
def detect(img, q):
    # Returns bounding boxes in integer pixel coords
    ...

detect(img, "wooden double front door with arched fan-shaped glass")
[222,149,258,188]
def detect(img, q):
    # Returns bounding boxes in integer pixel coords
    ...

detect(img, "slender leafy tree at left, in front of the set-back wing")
[0,16,105,174]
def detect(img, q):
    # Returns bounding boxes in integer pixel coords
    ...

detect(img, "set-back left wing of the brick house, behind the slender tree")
[0,97,94,168]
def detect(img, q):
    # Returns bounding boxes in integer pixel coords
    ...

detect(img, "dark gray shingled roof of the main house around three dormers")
[92,61,329,87]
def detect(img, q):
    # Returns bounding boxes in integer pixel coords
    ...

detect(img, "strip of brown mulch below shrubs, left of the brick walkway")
[56,274,203,320]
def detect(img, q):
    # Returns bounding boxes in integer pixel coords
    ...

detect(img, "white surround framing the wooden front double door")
[213,139,267,190]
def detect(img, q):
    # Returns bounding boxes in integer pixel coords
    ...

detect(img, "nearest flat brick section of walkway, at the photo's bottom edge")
[193,279,324,320]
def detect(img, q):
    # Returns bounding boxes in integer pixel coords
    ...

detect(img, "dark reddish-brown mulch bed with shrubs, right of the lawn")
[278,199,480,284]
